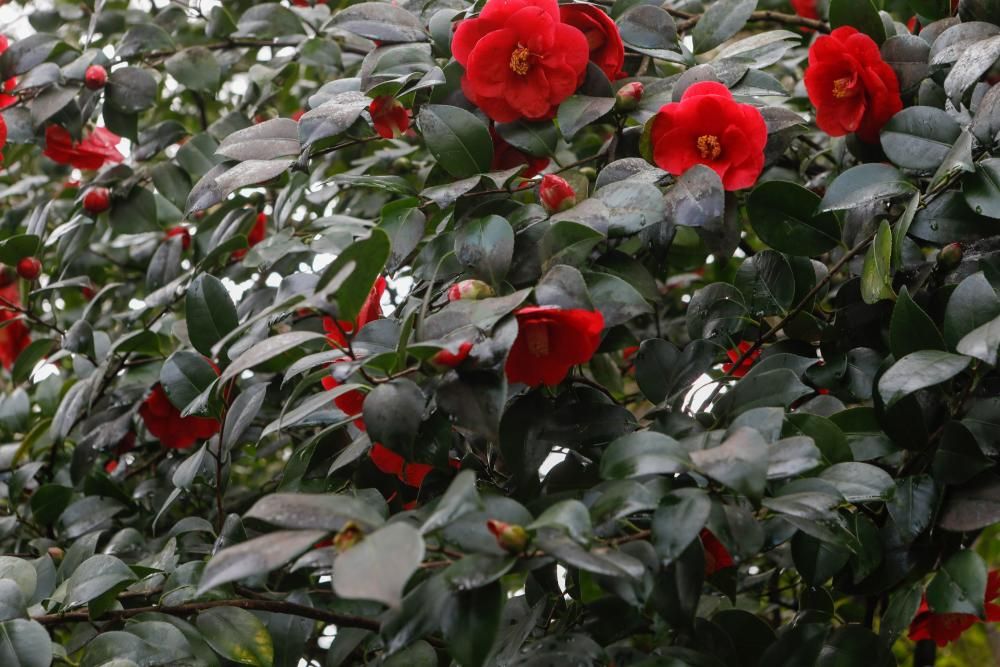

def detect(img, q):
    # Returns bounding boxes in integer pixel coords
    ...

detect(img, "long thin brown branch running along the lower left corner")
[31,600,379,632]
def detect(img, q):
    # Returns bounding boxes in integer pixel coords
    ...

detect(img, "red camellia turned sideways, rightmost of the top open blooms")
[805,26,903,143]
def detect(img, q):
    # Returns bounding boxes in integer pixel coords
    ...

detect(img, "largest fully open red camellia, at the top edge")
[451,0,590,123]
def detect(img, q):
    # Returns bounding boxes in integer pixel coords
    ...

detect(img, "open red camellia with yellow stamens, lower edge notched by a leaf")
[651,81,767,190]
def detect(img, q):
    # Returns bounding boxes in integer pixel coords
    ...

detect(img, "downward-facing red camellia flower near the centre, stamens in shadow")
[505,306,604,387]
